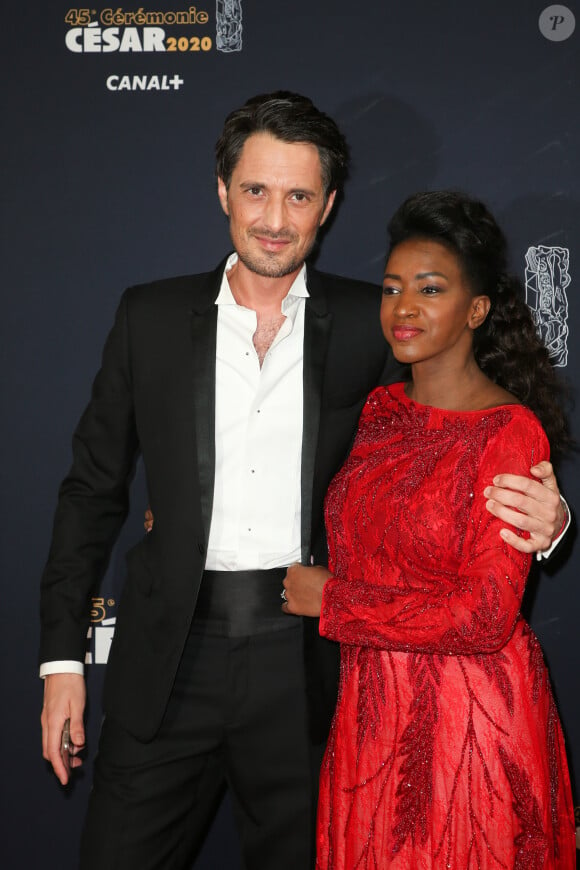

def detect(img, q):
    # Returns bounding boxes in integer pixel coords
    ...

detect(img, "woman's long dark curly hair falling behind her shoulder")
[388,190,572,455]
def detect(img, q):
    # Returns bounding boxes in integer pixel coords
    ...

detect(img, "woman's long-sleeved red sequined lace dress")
[317,384,576,870]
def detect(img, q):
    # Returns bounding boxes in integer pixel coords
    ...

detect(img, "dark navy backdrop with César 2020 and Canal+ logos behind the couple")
[0,0,580,870]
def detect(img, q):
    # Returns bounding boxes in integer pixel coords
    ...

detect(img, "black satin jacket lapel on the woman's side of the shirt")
[301,268,332,565]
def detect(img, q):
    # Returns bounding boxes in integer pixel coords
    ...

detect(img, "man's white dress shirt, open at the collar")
[206,254,308,571]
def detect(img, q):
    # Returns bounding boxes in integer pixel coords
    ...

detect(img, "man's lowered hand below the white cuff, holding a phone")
[40,674,86,785]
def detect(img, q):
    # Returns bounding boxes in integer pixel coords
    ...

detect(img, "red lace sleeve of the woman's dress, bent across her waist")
[320,415,549,655]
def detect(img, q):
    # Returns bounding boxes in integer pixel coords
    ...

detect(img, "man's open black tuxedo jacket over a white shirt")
[40,263,402,742]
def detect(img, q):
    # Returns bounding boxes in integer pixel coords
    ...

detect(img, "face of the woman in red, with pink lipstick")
[381,238,489,364]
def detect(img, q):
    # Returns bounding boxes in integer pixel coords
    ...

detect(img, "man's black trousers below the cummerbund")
[80,619,322,870]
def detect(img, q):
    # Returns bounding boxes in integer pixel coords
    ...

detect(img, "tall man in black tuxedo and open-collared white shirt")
[41,92,561,870]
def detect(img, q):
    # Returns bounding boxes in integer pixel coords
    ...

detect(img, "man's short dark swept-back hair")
[215,91,349,199]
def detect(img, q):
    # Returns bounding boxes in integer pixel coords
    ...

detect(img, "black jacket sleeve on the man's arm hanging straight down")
[40,294,138,662]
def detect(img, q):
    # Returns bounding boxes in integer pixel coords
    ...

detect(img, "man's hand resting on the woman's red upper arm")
[483,462,566,553]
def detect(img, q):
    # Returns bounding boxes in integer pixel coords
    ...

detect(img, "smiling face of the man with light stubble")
[218,133,335,278]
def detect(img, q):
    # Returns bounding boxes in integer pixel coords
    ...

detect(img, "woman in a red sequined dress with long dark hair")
[308,192,575,870]
